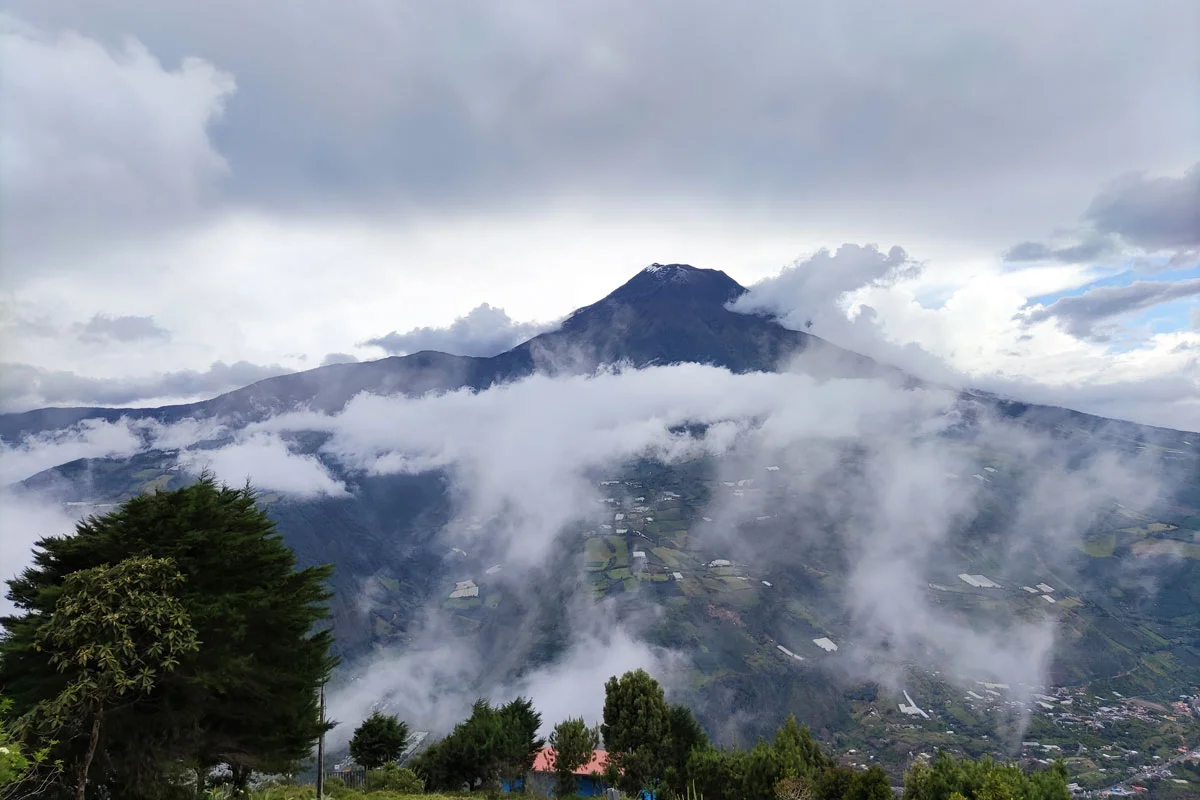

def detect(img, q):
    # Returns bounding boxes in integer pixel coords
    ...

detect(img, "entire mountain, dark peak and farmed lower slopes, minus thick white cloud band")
[9,265,1200,770]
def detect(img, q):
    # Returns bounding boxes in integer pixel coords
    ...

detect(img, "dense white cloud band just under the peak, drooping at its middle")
[258,365,953,564]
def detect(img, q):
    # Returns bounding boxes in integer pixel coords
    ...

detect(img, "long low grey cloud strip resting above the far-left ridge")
[0,361,292,411]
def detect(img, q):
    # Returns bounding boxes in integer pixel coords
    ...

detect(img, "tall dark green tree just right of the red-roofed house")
[601,669,670,794]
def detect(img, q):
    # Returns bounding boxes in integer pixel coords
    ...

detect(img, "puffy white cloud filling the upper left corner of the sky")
[0,14,234,271]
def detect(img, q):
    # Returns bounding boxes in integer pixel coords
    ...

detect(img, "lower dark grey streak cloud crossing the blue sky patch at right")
[1025,278,1200,341]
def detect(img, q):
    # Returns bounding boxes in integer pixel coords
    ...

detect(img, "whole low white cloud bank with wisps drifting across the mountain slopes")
[4,359,1180,740]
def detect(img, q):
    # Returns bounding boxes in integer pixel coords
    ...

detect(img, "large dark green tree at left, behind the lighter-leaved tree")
[0,476,335,800]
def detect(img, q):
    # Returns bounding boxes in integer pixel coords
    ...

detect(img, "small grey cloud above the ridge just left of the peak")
[362,302,546,356]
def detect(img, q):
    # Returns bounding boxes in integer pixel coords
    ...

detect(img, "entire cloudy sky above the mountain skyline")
[0,0,1200,429]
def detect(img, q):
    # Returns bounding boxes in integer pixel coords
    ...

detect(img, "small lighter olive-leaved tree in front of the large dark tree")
[23,557,199,800]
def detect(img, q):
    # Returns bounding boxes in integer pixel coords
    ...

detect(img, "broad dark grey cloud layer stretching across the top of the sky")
[11,0,1196,260]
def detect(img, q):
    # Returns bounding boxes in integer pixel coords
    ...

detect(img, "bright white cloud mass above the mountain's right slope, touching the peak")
[733,246,1200,431]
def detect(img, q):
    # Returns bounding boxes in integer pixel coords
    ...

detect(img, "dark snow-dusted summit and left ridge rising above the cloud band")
[0,264,883,441]
